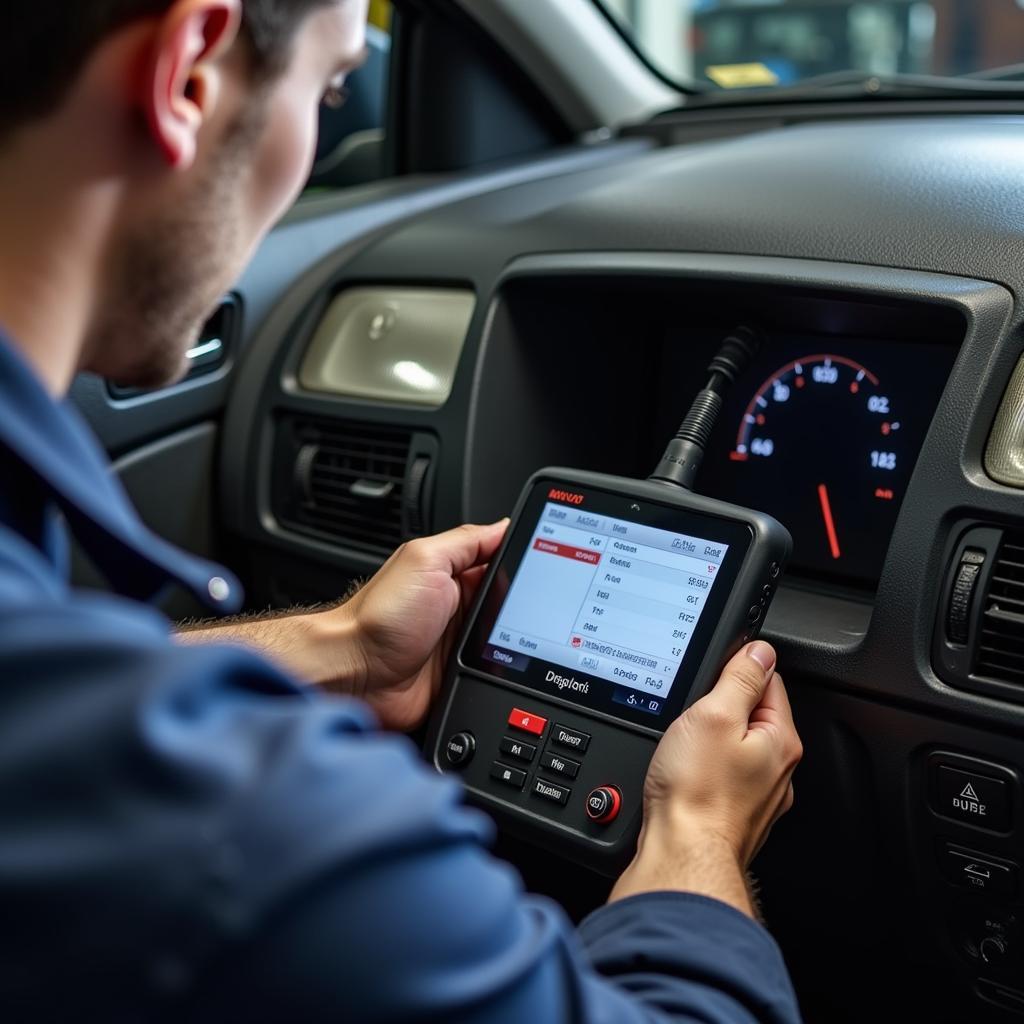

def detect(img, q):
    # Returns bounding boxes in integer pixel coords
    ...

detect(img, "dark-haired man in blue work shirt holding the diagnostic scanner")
[0,0,801,1024]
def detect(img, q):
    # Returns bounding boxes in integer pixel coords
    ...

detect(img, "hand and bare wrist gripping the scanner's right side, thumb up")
[610,641,803,916]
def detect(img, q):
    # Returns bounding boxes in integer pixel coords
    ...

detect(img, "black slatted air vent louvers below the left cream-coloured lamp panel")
[274,419,413,553]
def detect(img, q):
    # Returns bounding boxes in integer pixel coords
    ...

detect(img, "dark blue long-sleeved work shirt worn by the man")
[0,331,799,1024]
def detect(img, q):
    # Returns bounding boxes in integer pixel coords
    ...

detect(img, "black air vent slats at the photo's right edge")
[975,531,1024,689]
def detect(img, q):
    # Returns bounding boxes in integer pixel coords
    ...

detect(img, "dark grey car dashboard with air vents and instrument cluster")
[77,115,1024,1020]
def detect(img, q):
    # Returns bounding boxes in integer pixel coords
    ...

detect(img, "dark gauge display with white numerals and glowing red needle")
[697,334,956,589]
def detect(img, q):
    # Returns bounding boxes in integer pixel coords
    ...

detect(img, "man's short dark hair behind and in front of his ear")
[0,0,331,137]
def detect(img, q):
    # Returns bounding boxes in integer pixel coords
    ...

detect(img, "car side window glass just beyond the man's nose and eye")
[306,0,392,191]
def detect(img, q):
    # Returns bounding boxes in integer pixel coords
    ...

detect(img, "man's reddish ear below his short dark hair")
[142,0,242,170]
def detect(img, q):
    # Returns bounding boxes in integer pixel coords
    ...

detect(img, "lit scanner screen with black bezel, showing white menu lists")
[463,478,752,730]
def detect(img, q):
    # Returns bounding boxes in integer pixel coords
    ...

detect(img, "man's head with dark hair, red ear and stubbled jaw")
[0,0,367,385]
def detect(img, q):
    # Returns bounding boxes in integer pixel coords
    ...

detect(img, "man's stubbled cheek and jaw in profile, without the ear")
[84,0,368,387]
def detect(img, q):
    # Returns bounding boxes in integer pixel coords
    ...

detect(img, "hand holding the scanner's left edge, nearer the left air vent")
[321,519,508,730]
